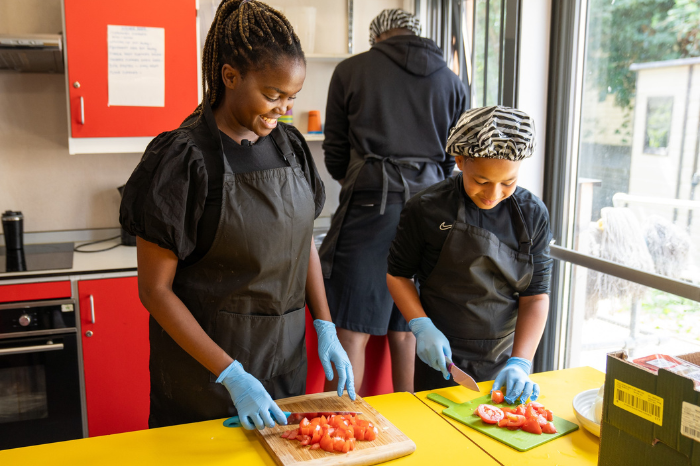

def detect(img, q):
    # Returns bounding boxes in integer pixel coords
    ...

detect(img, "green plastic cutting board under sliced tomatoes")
[428,393,578,451]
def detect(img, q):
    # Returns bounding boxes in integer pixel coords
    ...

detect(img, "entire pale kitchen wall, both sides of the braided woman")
[0,0,403,232]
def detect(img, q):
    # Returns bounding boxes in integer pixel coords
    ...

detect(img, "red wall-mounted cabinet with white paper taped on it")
[63,0,199,154]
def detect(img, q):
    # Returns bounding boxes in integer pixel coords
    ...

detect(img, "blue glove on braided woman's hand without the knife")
[314,319,355,400]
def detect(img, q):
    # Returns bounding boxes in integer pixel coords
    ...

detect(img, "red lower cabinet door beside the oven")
[78,277,150,437]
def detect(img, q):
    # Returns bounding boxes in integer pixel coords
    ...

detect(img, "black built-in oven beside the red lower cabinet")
[0,299,84,449]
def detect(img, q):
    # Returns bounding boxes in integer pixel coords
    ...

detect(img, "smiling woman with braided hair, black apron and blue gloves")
[120,0,355,429]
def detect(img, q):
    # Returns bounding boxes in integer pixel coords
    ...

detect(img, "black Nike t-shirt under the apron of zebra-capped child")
[388,173,553,296]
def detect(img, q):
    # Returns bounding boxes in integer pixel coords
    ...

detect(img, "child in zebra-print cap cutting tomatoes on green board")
[386,106,553,403]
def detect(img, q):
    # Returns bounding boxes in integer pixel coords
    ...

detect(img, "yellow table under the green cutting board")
[412,367,605,466]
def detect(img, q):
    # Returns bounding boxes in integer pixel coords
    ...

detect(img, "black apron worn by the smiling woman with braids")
[149,105,314,427]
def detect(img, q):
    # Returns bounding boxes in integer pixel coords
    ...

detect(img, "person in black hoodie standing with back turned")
[319,10,468,392]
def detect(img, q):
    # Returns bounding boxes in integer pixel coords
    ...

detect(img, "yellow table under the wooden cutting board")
[0,393,498,466]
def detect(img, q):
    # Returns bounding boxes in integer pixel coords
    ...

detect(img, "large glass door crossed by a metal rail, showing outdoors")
[550,0,700,371]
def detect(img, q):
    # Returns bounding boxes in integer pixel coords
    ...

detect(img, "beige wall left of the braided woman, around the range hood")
[0,0,140,232]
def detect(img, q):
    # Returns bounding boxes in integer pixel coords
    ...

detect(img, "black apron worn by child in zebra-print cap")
[414,191,534,391]
